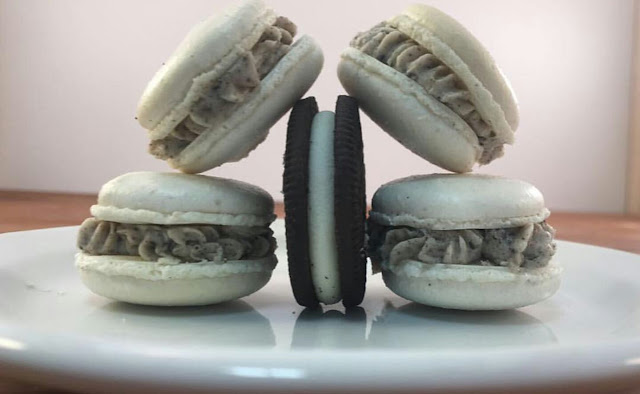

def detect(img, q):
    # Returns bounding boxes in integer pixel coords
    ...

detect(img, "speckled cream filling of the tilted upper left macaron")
[149,16,297,160]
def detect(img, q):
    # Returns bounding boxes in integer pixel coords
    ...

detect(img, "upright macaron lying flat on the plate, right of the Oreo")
[368,174,562,310]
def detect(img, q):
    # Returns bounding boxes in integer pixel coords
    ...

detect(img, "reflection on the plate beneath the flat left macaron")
[79,300,276,347]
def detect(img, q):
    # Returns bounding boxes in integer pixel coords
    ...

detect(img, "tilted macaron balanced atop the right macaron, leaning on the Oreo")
[338,5,519,172]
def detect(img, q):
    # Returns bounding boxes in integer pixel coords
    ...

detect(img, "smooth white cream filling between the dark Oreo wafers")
[308,111,342,304]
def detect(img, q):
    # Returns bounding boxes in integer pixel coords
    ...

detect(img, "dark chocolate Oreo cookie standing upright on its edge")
[283,96,366,307]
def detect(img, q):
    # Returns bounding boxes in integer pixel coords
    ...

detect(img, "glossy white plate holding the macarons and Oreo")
[0,221,640,393]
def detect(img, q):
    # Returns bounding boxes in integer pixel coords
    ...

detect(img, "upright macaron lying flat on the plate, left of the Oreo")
[76,172,277,306]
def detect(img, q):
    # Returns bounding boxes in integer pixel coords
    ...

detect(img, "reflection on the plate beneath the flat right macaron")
[369,302,558,350]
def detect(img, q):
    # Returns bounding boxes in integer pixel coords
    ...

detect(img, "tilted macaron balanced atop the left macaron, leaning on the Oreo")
[137,0,323,173]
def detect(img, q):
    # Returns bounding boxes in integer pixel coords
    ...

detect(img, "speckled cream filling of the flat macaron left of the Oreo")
[77,218,276,263]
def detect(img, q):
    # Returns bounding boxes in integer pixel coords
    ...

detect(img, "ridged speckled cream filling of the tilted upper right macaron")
[351,22,504,164]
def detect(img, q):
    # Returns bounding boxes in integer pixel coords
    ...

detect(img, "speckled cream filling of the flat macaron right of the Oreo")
[368,220,556,270]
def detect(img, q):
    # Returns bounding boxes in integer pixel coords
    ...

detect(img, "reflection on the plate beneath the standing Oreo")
[291,307,367,349]
